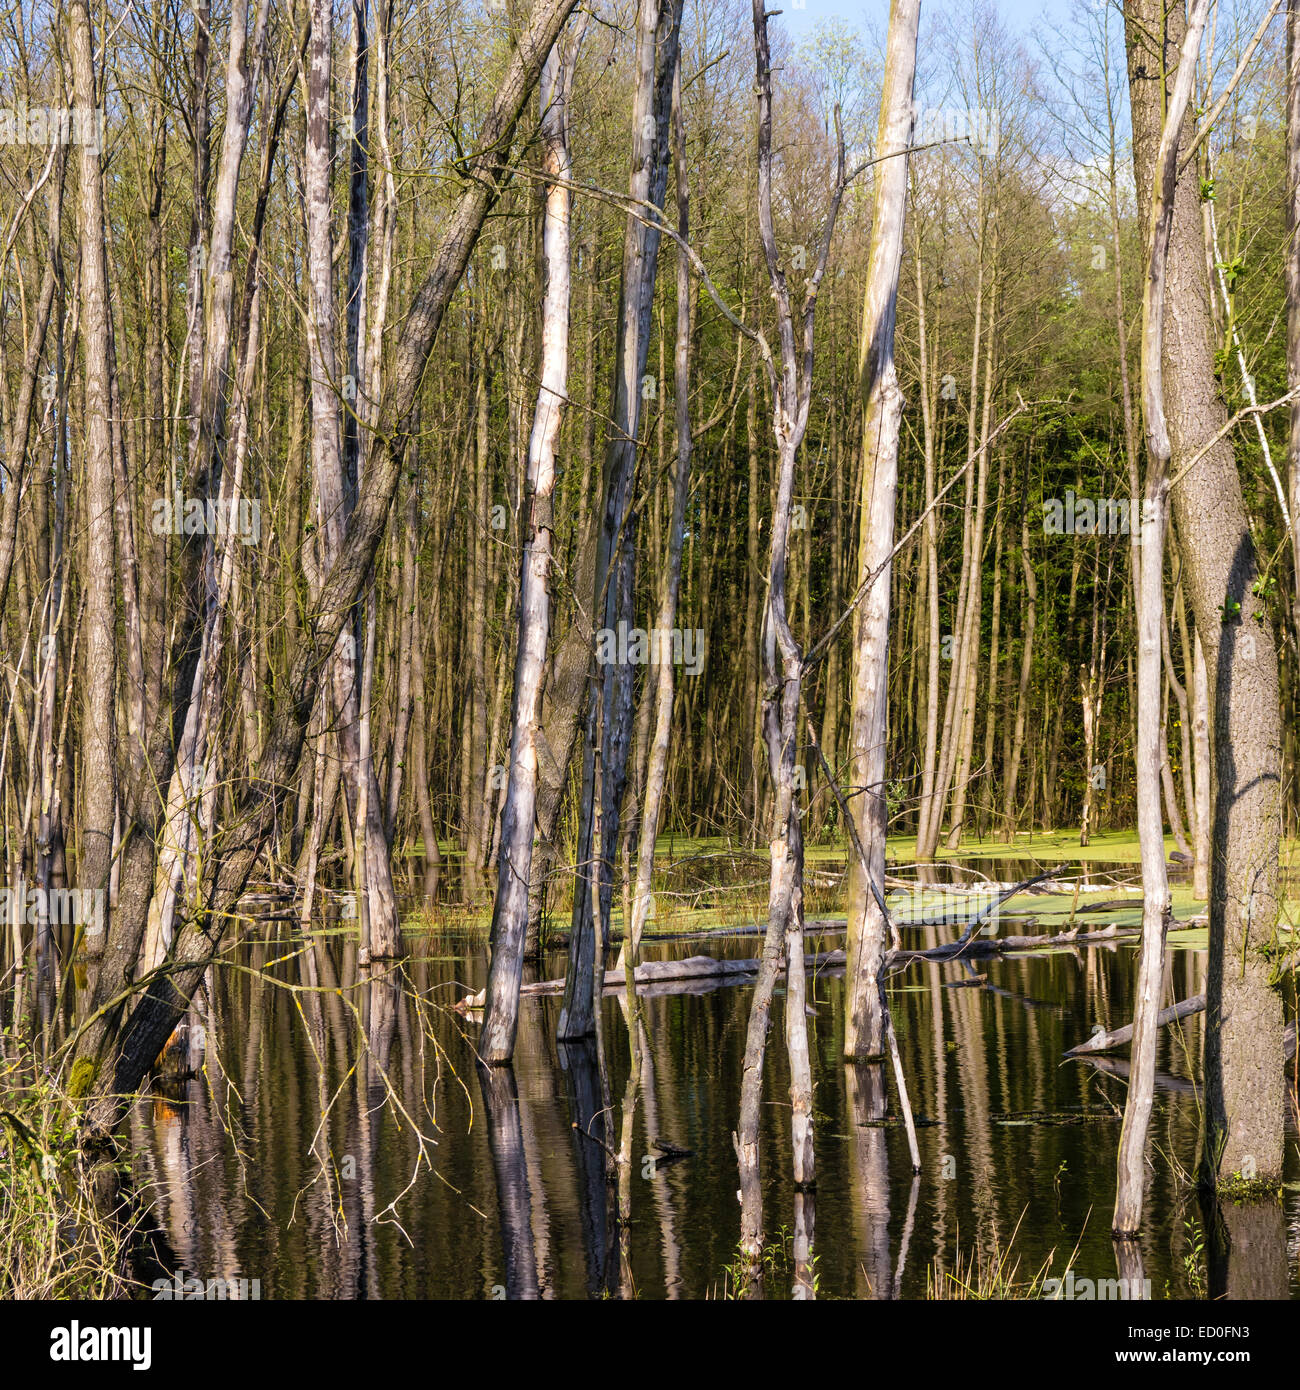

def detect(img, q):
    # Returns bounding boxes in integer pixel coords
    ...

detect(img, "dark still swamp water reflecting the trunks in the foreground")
[131,878,1300,1298]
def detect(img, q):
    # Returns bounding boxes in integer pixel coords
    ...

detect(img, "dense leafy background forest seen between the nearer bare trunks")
[0,3,1297,895]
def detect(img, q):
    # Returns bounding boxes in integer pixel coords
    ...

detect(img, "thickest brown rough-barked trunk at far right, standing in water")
[1125,0,1285,1206]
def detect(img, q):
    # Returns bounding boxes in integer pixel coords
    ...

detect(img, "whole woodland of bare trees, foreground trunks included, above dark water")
[0,0,1300,1297]
